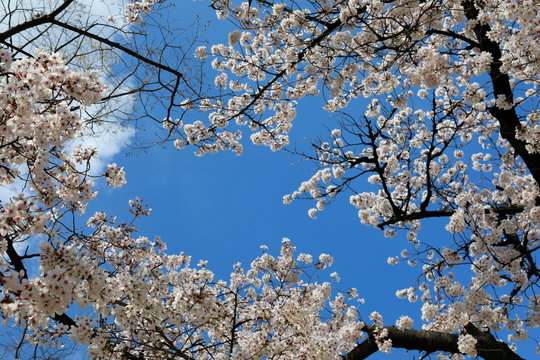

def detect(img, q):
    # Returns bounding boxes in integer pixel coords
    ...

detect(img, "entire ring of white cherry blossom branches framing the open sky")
[0,0,540,360]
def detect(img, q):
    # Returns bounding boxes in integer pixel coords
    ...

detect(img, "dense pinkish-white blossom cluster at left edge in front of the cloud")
[0,50,104,231]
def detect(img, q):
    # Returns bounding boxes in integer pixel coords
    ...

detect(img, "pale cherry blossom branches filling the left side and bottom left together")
[0,0,363,359]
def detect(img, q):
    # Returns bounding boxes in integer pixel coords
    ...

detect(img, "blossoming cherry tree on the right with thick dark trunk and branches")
[168,0,540,359]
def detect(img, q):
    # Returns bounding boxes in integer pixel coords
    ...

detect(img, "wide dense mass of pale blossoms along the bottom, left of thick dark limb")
[0,224,364,360]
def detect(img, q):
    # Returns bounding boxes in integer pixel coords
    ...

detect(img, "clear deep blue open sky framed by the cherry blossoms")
[82,1,532,359]
